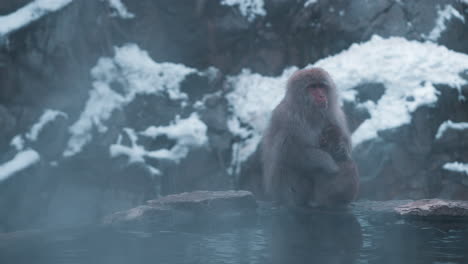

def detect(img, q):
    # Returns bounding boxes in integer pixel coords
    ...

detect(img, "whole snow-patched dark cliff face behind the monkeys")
[0,0,468,230]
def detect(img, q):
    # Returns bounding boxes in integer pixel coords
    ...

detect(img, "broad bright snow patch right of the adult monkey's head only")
[314,36,468,145]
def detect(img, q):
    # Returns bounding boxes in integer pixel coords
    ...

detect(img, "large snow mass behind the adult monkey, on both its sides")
[227,36,468,163]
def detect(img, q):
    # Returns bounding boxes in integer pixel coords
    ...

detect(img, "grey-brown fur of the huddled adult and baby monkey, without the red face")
[261,68,358,206]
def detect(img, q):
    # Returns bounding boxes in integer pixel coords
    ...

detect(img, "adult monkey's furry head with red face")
[286,68,337,110]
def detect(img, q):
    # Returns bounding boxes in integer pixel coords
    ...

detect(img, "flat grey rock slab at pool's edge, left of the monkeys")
[103,191,257,229]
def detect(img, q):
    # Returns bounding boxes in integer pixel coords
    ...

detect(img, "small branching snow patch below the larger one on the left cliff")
[110,113,208,174]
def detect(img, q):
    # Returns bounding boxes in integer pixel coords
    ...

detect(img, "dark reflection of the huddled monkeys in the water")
[271,210,362,263]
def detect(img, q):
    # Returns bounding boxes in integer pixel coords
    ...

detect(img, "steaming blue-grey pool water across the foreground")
[0,203,468,264]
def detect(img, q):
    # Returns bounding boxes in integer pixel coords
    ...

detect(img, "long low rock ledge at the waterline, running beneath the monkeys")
[102,196,468,230]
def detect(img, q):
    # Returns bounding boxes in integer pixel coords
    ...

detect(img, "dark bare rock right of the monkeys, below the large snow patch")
[354,86,468,200]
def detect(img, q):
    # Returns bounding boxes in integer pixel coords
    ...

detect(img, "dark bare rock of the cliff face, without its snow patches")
[0,0,468,230]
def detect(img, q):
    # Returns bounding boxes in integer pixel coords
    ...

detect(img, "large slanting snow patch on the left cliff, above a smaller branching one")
[63,44,196,157]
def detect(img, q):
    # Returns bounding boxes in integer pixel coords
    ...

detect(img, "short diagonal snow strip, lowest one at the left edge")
[0,149,40,182]
